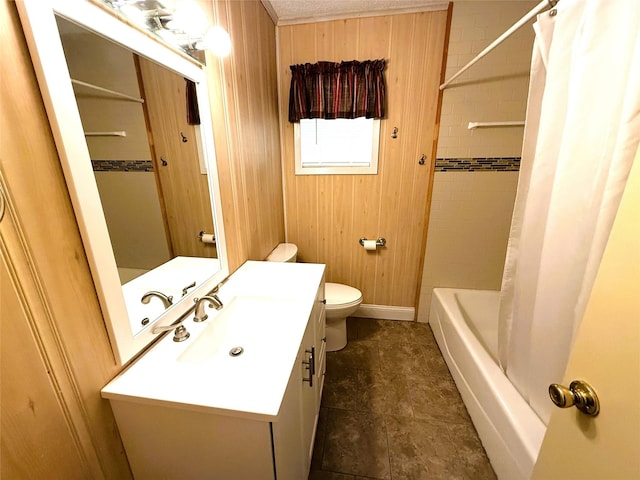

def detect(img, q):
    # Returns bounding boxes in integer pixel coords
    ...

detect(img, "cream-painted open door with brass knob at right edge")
[533,150,640,480]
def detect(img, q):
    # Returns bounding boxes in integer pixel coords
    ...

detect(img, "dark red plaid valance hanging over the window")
[289,60,386,122]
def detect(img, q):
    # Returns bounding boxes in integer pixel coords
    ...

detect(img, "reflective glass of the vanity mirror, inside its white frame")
[56,17,218,335]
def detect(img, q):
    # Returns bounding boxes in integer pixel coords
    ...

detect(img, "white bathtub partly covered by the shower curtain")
[429,288,546,480]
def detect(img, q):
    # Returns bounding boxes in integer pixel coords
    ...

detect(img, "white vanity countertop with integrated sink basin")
[102,261,324,421]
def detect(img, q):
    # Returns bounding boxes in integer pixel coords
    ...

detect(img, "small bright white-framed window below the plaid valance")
[294,117,380,175]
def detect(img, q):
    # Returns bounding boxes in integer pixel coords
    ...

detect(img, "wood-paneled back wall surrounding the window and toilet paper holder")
[278,11,448,307]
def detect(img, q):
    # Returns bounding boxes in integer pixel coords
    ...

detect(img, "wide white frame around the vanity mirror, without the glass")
[16,0,229,365]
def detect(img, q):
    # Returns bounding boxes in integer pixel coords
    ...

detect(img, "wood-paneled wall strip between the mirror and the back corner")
[207,0,284,272]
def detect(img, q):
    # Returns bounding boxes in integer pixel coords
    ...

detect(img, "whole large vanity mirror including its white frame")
[18,0,228,363]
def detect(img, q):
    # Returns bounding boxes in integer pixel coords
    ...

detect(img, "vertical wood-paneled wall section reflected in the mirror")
[138,57,217,258]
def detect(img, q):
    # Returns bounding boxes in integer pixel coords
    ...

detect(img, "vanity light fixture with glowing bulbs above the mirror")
[102,0,231,57]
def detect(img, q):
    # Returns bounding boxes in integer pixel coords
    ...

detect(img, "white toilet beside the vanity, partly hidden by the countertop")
[266,243,362,352]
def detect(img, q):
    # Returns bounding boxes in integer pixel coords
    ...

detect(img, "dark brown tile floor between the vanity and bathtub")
[309,318,496,480]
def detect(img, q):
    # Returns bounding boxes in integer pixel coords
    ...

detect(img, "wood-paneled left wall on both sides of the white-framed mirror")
[0,0,284,472]
